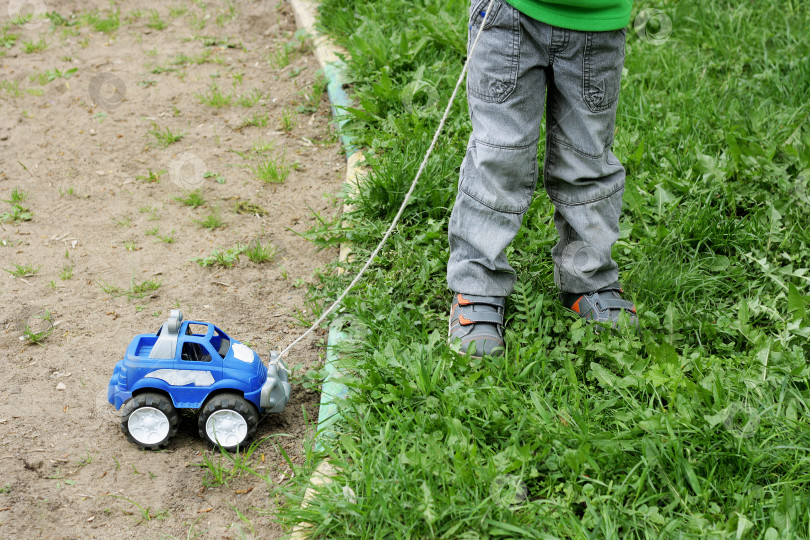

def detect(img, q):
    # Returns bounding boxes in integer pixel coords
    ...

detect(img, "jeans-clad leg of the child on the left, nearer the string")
[447,0,548,297]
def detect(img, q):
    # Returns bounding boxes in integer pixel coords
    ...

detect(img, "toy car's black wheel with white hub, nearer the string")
[197,393,259,452]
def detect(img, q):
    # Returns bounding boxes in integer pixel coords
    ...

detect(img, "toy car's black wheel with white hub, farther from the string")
[121,392,180,450]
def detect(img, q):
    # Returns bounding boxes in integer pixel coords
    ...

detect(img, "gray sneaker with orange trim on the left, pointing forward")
[447,293,506,358]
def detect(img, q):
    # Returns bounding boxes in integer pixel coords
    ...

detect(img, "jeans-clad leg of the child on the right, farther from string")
[543,28,625,294]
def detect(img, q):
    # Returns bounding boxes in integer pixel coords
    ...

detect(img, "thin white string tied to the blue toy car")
[279,0,495,357]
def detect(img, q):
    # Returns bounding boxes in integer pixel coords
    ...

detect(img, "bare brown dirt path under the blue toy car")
[0,0,343,538]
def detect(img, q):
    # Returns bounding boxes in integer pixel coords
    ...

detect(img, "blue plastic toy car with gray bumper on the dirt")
[107,309,290,451]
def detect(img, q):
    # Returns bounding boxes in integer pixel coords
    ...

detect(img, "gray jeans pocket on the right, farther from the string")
[582,29,625,112]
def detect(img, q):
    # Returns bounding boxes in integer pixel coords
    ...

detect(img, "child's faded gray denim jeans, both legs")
[447,0,625,296]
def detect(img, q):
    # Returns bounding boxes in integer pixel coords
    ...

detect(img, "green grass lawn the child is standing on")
[281,0,810,539]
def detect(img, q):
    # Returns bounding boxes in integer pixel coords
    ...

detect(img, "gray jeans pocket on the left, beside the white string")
[467,0,520,103]
